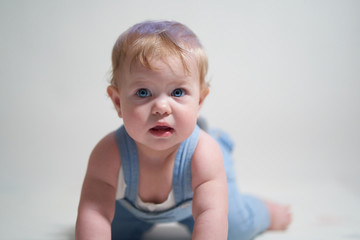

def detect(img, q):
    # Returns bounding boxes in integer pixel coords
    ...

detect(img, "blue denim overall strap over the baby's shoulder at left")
[115,126,139,204]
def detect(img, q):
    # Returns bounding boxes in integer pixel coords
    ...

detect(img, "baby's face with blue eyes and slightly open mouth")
[119,57,201,150]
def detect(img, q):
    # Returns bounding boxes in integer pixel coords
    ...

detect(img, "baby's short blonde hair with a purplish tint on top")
[110,21,208,91]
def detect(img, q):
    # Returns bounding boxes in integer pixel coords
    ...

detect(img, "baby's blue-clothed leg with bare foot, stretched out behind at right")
[211,130,291,240]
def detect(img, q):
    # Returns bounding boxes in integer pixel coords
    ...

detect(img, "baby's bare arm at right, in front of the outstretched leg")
[192,131,228,240]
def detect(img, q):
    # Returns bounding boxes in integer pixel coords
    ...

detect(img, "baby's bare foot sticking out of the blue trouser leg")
[264,200,291,231]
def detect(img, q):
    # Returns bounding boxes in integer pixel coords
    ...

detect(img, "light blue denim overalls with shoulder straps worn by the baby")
[111,126,269,240]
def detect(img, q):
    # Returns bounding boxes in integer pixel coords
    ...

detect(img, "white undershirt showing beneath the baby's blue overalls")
[116,167,175,212]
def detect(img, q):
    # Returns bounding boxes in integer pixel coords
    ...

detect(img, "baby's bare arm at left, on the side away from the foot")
[76,133,120,240]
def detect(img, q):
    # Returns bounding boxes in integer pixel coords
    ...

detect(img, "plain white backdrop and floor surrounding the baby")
[0,0,360,240]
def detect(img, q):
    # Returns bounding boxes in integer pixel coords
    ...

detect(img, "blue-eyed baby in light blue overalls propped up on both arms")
[76,21,291,240]
